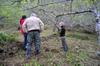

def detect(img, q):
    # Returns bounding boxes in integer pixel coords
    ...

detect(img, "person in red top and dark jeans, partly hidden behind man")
[20,15,27,49]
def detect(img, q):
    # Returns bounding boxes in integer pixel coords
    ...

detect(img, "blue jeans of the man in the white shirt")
[26,31,41,58]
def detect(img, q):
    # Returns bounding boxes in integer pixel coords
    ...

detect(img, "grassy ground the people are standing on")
[0,30,100,66]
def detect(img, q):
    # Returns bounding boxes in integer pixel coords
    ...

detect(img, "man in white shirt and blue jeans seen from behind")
[22,13,44,59]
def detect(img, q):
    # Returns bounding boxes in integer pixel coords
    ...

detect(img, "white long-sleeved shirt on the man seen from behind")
[22,16,44,32]
